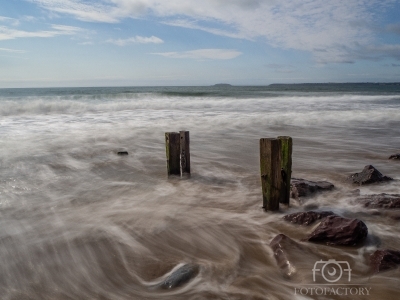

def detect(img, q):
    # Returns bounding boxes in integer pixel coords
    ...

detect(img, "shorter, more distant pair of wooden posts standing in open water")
[165,131,190,177]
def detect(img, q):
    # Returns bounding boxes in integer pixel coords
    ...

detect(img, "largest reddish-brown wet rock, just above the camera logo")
[306,216,368,246]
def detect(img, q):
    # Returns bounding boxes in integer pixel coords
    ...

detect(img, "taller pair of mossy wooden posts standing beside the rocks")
[260,136,293,211]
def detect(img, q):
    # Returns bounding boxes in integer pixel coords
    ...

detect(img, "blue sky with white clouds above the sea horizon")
[0,0,400,88]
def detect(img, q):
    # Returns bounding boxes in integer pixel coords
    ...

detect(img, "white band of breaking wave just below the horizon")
[0,92,400,116]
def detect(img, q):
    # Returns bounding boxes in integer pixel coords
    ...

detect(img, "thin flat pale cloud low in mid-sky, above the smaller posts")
[152,49,242,60]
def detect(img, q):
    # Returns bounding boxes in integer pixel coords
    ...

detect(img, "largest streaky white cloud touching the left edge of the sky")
[0,25,82,41]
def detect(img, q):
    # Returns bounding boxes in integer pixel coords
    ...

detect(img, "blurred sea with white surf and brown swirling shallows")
[0,83,400,300]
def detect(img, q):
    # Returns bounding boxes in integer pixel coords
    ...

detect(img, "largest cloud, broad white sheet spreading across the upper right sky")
[25,0,397,63]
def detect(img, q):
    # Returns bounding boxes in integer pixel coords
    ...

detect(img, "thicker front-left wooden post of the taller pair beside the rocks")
[260,138,282,211]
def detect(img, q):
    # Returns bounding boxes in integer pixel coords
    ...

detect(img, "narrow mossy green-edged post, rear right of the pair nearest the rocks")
[278,136,293,205]
